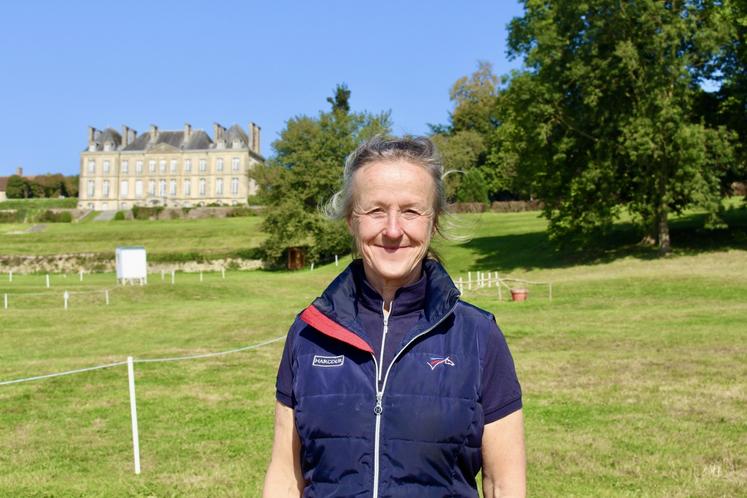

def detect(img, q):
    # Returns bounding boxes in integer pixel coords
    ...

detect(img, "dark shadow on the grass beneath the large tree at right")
[464,207,747,271]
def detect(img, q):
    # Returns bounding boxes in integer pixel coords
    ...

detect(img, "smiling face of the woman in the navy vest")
[348,160,435,286]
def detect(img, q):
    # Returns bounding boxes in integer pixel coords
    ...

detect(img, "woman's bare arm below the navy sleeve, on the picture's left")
[262,401,304,498]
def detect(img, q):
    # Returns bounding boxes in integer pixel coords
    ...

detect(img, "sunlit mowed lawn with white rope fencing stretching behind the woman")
[0,208,747,497]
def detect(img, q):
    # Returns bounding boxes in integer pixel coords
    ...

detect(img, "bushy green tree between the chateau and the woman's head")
[252,85,390,264]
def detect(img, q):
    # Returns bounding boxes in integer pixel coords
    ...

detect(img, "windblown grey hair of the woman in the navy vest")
[324,135,448,236]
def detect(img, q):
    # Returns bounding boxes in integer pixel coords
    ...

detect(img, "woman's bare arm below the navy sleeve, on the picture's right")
[482,410,526,498]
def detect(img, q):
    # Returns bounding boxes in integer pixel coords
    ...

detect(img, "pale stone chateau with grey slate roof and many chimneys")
[78,123,264,211]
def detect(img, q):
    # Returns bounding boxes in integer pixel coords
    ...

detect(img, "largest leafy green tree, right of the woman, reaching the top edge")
[498,0,733,252]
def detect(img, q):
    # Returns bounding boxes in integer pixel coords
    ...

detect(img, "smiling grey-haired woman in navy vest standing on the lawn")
[264,137,525,498]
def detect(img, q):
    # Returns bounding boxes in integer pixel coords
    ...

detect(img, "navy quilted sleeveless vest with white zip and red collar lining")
[291,260,493,498]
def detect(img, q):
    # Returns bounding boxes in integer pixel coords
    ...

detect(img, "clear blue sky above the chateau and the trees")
[0,0,521,175]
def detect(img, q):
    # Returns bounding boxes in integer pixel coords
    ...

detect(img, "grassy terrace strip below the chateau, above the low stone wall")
[0,216,264,257]
